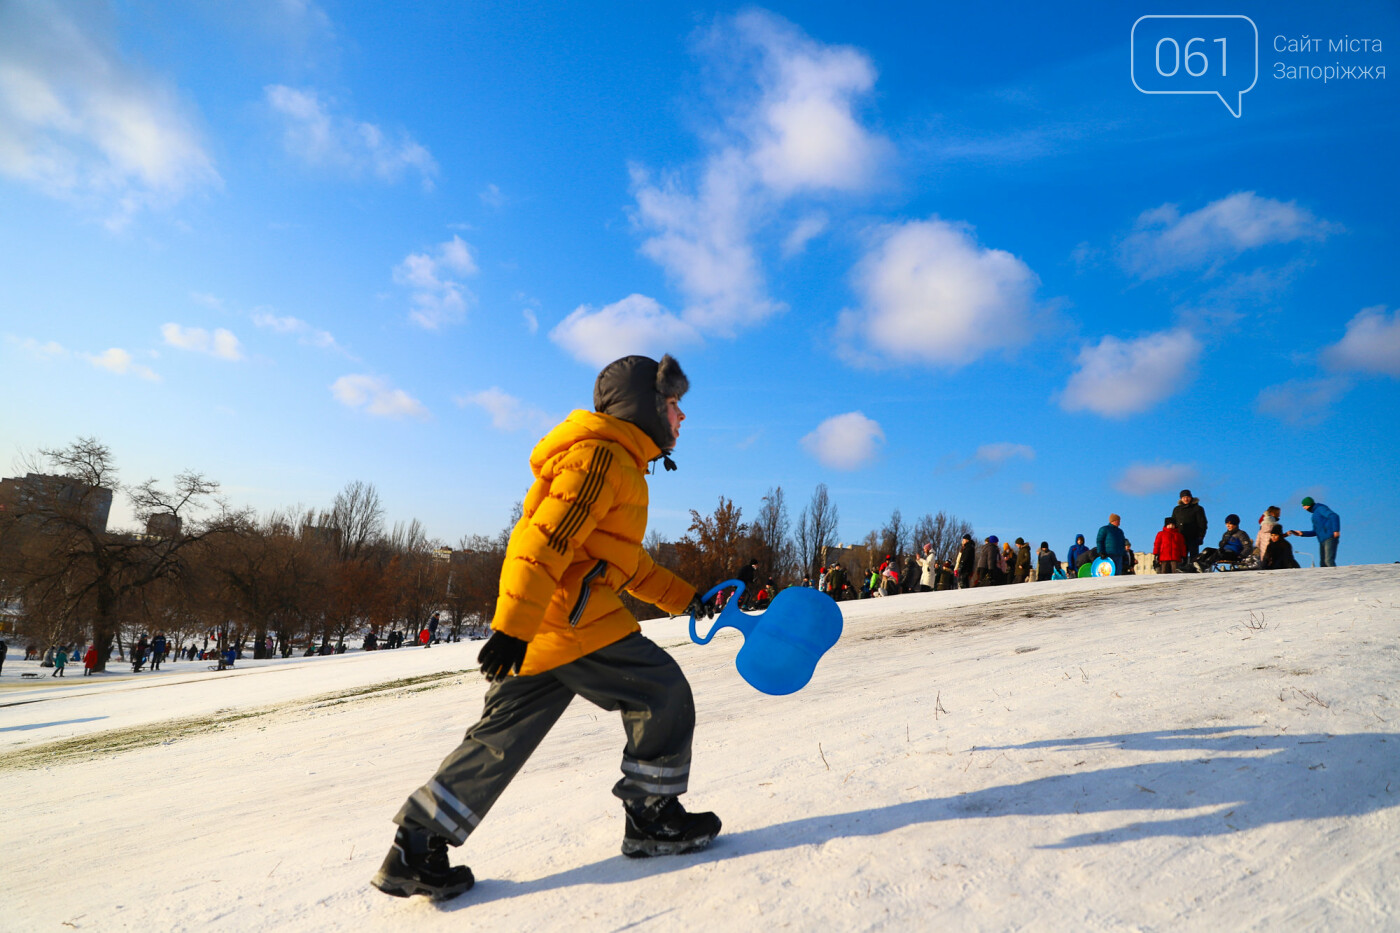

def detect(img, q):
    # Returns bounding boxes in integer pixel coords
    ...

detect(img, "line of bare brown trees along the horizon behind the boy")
[0,437,970,670]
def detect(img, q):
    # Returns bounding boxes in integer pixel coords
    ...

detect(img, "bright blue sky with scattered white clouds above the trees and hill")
[0,0,1400,563]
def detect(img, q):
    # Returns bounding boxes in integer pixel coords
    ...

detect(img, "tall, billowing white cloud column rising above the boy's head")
[552,11,890,363]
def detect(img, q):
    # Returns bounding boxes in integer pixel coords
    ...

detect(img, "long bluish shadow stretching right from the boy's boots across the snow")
[441,726,1400,911]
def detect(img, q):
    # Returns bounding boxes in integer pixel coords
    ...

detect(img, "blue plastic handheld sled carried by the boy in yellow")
[690,580,841,696]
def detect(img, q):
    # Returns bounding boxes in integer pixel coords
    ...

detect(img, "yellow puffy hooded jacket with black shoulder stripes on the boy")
[491,410,694,675]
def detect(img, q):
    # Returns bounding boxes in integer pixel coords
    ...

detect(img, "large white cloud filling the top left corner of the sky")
[0,3,220,227]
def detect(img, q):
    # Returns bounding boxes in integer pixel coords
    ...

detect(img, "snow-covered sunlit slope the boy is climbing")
[0,566,1400,932]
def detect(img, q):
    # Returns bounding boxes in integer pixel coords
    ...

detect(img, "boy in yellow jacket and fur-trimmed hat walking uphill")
[371,356,720,899]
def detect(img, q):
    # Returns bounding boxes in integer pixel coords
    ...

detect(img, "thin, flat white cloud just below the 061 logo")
[1119,191,1340,279]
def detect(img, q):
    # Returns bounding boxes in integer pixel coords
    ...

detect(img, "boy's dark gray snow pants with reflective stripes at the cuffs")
[393,632,696,846]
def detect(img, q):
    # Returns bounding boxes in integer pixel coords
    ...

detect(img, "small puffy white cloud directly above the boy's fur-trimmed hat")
[549,294,700,366]
